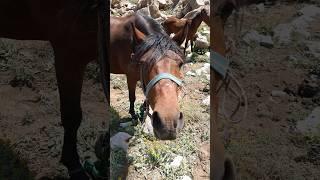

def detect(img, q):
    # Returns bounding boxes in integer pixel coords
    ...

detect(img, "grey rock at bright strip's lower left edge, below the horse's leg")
[110,132,132,151]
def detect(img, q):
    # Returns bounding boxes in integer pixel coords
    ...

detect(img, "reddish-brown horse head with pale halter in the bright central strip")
[133,23,184,140]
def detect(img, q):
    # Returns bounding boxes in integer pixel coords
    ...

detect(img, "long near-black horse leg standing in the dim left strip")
[55,55,89,180]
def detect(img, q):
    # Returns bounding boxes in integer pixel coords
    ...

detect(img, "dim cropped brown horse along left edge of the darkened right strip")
[210,0,264,180]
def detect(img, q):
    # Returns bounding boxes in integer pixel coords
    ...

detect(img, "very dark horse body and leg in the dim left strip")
[0,0,109,180]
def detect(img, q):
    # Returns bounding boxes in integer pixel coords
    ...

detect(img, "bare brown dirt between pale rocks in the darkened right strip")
[221,4,320,179]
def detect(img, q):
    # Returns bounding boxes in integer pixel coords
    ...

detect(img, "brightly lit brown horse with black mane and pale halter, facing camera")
[110,13,185,140]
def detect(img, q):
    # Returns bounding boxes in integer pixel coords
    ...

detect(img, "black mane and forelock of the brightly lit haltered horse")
[134,33,185,69]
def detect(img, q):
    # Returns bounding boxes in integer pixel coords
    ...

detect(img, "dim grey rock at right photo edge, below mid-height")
[297,106,320,134]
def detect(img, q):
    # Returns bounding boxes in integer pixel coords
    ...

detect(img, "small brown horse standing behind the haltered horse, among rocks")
[162,7,209,51]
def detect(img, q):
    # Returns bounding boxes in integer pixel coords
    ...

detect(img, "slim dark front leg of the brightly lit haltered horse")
[127,75,138,119]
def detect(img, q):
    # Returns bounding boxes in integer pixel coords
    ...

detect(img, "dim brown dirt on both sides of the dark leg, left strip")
[0,39,107,179]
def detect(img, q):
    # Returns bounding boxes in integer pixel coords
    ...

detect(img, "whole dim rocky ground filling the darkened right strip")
[221,2,320,179]
